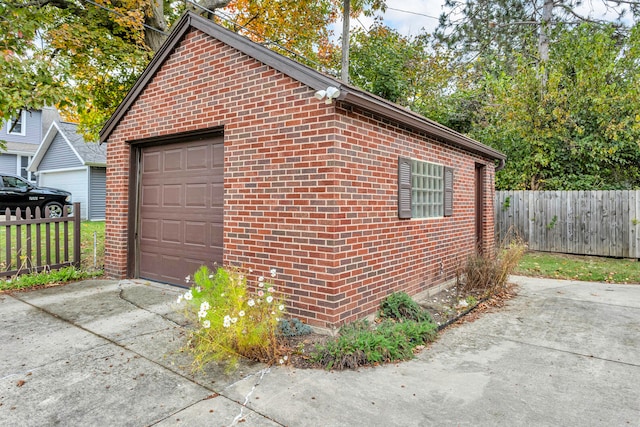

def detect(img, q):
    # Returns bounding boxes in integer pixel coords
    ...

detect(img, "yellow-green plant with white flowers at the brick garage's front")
[177,267,285,370]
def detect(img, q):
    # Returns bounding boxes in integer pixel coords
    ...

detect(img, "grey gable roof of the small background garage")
[28,121,107,172]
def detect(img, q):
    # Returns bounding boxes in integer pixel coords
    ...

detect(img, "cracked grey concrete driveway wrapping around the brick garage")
[0,277,640,427]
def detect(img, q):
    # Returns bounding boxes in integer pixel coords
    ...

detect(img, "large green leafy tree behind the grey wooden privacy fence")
[472,24,640,190]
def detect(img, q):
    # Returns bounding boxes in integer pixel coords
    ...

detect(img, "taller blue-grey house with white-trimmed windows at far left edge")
[0,107,60,181]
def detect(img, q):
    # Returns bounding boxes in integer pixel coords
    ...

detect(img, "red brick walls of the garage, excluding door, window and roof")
[105,30,493,326]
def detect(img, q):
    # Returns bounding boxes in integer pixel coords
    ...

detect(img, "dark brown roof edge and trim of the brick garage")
[100,12,506,166]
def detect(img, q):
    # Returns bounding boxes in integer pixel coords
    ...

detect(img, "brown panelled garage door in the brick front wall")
[138,138,224,285]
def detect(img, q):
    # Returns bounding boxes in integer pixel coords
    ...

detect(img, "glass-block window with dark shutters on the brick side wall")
[398,157,453,218]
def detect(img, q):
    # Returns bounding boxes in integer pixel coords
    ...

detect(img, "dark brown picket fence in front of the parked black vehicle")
[0,203,80,277]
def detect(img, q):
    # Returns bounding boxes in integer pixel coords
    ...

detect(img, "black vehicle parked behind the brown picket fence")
[0,174,71,218]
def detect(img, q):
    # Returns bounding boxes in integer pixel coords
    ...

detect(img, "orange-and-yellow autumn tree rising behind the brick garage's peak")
[0,0,384,139]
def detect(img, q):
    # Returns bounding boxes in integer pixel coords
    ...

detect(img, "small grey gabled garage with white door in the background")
[28,122,107,220]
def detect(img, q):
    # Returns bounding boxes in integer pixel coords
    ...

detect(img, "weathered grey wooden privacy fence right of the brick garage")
[495,190,640,258]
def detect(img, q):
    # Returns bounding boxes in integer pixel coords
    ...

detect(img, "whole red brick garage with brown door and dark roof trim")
[101,13,505,327]
